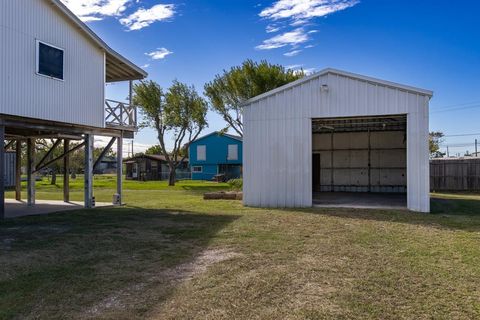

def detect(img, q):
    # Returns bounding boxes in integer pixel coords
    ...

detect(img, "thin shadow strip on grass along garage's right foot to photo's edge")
[284,198,480,232]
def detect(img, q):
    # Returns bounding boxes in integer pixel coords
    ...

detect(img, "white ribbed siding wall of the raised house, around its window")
[0,0,105,127]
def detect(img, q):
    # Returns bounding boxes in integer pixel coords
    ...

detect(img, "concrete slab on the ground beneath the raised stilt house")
[5,199,113,218]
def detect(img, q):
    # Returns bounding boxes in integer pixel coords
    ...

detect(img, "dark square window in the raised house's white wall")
[37,41,63,80]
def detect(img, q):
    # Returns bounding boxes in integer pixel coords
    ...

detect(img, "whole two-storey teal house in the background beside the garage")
[188,132,243,180]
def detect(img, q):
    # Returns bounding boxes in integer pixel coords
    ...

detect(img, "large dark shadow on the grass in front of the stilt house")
[0,207,238,318]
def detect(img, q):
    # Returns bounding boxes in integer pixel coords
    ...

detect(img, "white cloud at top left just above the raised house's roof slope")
[62,0,132,22]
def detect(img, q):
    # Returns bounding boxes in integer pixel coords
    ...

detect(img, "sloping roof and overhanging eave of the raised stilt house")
[48,0,148,82]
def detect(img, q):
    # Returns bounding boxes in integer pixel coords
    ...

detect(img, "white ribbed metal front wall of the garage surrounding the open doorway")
[243,73,430,212]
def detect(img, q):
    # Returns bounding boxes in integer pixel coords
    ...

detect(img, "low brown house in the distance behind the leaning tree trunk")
[124,154,190,181]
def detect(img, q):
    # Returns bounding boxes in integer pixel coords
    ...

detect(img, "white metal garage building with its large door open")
[243,69,433,212]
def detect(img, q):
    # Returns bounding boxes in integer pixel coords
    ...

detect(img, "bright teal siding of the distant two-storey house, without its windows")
[189,134,243,180]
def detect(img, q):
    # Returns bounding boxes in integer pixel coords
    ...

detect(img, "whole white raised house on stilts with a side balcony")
[0,0,147,217]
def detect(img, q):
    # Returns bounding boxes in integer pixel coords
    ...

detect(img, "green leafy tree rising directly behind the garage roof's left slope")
[204,60,305,136]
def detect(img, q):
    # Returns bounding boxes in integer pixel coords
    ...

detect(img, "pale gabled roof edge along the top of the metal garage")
[243,68,433,106]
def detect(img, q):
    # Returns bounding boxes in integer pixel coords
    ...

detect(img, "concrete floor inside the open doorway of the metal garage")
[313,192,407,209]
